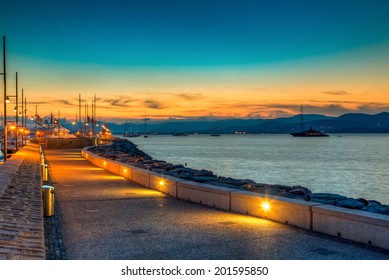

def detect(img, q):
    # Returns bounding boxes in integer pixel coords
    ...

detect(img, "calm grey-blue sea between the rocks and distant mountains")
[124,134,389,204]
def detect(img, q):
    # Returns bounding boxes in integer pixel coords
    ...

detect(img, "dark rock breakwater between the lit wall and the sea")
[89,139,389,215]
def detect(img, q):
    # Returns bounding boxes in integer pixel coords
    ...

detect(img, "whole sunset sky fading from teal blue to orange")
[0,0,389,122]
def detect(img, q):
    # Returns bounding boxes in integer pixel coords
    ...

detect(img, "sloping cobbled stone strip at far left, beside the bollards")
[0,144,46,260]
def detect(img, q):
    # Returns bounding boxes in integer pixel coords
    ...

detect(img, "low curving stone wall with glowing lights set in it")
[82,148,389,250]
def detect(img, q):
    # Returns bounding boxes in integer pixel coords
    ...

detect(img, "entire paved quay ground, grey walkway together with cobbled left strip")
[0,145,389,260]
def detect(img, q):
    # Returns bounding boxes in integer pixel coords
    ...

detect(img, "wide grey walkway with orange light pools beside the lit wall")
[46,150,389,260]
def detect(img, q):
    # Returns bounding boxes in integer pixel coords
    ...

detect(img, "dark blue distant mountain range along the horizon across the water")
[62,112,389,134]
